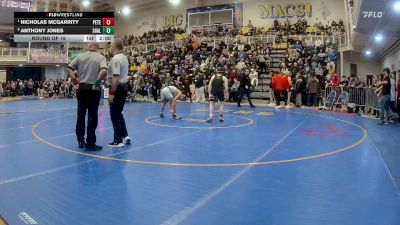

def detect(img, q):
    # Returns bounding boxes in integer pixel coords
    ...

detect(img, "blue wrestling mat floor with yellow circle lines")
[0,100,400,225]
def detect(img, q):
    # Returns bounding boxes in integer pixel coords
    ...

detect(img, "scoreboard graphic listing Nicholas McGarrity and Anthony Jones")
[14,12,114,42]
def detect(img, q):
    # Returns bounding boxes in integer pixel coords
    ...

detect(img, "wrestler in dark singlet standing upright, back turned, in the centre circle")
[207,67,229,123]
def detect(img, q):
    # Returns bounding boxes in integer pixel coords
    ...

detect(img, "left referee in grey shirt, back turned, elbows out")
[67,43,107,151]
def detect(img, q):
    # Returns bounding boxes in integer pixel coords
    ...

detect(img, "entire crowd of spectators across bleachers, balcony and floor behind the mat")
[0,19,396,121]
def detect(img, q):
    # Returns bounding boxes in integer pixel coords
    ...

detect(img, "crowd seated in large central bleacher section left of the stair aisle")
[124,35,271,102]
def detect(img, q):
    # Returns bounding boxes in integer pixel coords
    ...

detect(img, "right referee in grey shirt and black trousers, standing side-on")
[107,38,131,147]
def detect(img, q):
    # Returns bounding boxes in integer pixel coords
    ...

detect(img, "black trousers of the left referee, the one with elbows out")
[75,84,101,146]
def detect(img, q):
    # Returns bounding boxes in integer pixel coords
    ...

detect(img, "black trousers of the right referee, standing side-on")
[110,84,128,143]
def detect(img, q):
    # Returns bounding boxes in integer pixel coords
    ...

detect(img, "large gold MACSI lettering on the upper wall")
[258,2,312,19]
